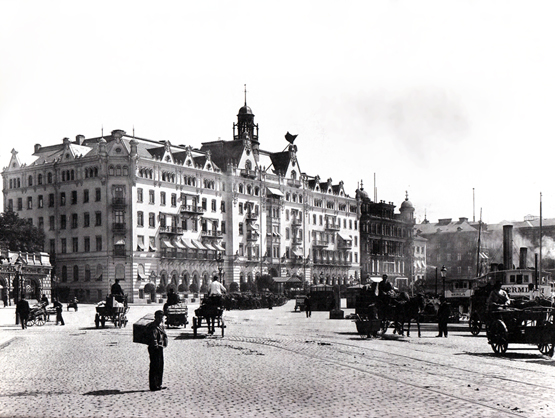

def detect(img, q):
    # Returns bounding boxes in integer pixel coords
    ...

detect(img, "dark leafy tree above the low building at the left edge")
[0,211,45,253]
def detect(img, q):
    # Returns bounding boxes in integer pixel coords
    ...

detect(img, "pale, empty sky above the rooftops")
[0,0,555,223]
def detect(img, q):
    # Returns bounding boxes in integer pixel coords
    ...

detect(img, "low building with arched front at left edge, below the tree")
[0,249,52,304]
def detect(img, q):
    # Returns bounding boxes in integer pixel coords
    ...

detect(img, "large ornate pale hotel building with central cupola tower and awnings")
[2,100,360,301]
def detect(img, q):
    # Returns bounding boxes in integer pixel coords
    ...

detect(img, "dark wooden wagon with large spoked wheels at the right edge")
[486,306,555,357]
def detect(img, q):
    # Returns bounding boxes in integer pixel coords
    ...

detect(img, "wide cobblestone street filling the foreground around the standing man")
[0,301,555,417]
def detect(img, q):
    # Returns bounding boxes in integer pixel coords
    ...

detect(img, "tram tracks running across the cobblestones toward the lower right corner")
[222,336,555,417]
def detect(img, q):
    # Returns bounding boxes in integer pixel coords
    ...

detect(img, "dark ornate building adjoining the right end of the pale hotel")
[356,186,416,290]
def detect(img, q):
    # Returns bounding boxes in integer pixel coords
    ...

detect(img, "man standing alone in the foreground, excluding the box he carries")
[148,311,168,391]
